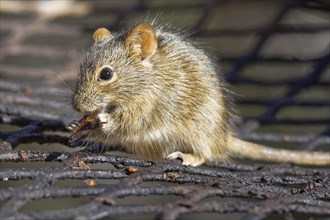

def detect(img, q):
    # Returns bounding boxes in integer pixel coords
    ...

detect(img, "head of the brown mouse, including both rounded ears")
[72,23,158,114]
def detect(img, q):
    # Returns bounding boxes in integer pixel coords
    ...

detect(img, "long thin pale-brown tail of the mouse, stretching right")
[228,137,330,166]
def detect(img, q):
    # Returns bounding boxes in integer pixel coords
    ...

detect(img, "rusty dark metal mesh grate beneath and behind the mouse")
[0,0,330,219]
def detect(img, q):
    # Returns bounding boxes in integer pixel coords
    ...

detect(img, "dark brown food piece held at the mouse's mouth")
[68,112,101,146]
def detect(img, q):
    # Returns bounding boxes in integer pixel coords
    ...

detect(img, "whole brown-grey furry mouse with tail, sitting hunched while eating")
[72,22,330,166]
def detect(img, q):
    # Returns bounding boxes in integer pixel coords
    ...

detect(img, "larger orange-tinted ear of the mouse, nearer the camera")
[124,22,158,60]
